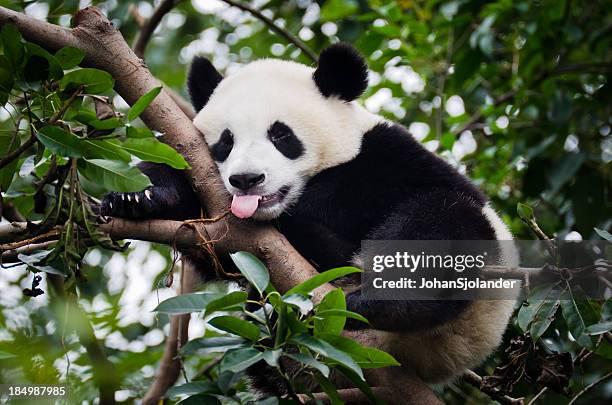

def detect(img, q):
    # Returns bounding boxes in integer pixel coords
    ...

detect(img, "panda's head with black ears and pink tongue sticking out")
[188,44,379,220]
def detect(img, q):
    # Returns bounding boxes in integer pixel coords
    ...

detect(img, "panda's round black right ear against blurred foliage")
[313,43,368,101]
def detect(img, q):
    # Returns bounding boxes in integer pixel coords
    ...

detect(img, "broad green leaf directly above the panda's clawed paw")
[79,159,151,192]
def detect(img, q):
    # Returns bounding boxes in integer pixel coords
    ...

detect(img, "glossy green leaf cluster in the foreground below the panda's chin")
[157,252,399,401]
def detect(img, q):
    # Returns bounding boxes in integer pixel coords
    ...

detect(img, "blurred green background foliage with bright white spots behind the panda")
[0,0,612,403]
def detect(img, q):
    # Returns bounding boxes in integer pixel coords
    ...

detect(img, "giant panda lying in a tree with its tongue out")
[102,43,514,392]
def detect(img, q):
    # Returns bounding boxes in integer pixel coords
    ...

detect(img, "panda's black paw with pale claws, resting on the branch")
[100,187,170,219]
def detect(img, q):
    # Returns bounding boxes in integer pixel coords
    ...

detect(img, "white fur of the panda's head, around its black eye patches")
[194,59,383,219]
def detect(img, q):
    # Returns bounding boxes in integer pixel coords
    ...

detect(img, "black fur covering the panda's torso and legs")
[102,124,495,330]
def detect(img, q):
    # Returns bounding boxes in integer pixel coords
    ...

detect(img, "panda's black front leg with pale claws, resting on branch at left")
[100,162,200,220]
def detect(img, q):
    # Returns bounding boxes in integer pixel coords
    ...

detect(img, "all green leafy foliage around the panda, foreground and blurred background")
[0,0,612,403]
